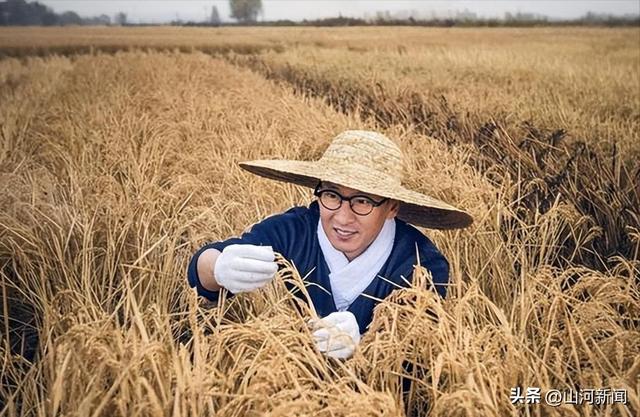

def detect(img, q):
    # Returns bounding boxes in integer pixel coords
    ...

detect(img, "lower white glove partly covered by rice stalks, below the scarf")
[309,311,360,359]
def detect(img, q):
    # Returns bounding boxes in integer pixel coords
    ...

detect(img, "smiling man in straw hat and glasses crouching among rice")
[188,130,472,358]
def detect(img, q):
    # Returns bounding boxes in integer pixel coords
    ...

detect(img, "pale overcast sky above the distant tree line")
[40,0,640,23]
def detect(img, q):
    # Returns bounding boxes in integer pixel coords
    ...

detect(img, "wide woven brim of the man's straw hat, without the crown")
[239,160,473,229]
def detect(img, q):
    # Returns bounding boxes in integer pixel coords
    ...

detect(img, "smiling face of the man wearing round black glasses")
[318,181,399,261]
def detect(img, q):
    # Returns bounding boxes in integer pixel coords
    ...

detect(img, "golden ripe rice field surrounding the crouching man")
[0,28,640,417]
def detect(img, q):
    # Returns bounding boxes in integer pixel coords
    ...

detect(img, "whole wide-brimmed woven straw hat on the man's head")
[240,130,473,229]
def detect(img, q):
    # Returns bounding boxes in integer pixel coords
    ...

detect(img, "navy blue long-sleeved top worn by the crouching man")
[187,201,449,333]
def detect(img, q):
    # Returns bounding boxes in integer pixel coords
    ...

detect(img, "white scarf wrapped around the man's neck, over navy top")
[318,219,396,311]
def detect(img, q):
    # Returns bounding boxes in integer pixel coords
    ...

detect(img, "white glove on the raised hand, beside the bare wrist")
[213,245,278,294]
